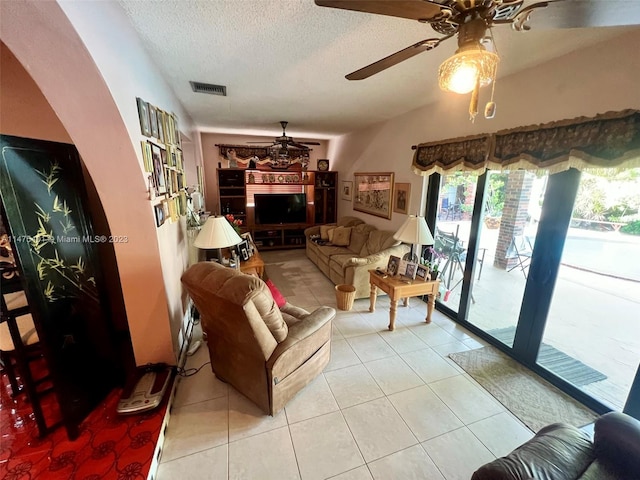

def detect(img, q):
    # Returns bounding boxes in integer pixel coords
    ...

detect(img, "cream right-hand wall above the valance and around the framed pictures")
[329,29,640,230]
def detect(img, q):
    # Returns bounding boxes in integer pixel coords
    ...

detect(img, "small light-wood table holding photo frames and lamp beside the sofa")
[369,270,440,330]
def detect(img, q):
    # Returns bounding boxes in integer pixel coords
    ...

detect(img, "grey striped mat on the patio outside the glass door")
[487,326,607,387]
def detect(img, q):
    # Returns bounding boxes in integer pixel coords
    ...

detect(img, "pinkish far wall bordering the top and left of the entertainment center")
[201,132,334,213]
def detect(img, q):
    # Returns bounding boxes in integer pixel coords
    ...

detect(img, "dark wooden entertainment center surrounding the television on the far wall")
[217,168,338,250]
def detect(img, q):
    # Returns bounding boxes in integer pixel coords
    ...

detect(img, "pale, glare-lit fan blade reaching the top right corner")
[514,0,640,30]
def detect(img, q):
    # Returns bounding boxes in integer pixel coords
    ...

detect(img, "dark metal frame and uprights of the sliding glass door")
[425,168,640,419]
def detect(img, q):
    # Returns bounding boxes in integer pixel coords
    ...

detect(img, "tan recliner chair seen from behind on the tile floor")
[182,262,336,415]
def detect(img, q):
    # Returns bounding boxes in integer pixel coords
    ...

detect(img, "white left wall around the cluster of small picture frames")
[59,0,202,360]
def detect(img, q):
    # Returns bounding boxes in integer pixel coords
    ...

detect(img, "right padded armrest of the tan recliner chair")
[267,307,336,383]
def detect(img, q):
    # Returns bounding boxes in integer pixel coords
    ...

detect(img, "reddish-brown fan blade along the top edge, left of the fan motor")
[315,0,440,21]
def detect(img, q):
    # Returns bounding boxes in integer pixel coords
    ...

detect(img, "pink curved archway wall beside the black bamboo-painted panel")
[0,2,175,364]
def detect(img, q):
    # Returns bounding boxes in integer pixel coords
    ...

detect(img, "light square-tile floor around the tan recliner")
[156,250,533,480]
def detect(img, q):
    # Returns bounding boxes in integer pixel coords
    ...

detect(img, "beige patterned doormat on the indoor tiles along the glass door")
[449,346,598,432]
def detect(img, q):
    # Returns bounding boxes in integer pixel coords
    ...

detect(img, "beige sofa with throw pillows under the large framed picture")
[304,217,410,298]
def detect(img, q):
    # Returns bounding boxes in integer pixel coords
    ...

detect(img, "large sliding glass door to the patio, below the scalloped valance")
[427,169,640,411]
